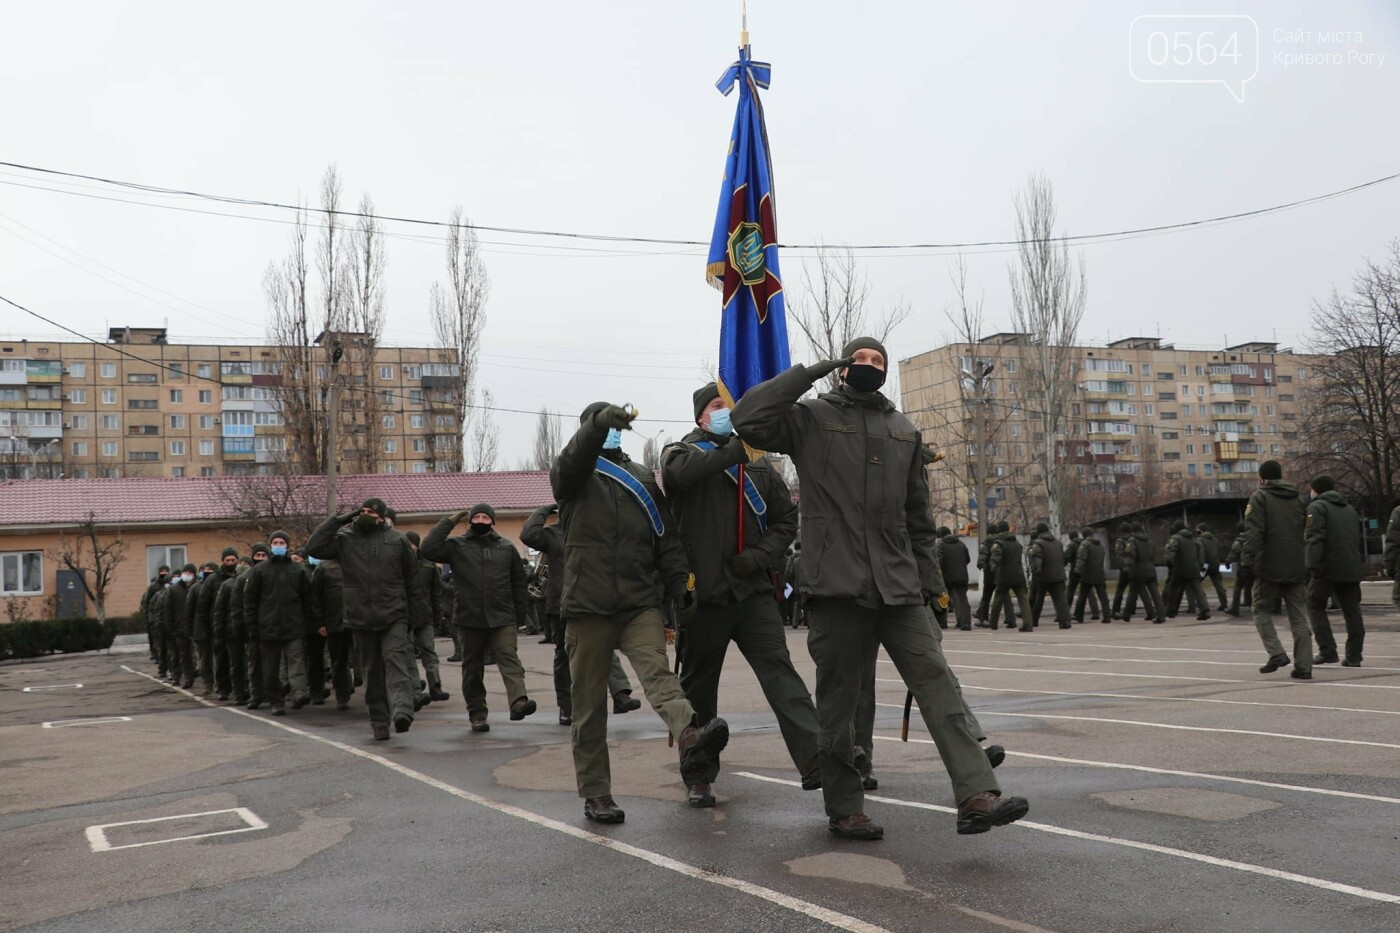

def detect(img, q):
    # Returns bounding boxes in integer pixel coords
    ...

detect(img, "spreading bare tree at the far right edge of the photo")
[1298,240,1400,517]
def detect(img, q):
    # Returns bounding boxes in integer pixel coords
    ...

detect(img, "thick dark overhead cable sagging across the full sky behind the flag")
[0,161,1400,251]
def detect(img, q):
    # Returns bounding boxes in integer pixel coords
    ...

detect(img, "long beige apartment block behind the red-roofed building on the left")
[0,328,461,479]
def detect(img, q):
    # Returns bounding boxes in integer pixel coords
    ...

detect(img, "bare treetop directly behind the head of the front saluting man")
[787,245,913,388]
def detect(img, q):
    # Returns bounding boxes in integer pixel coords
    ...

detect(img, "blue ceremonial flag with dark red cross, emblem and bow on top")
[706,45,791,406]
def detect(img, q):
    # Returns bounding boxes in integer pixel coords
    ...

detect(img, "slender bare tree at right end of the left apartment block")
[423,207,491,471]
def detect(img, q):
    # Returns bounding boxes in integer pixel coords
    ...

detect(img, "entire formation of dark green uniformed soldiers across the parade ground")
[141,338,1400,839]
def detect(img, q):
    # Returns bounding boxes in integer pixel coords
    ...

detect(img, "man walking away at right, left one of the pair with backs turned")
[1240,459,1312,681]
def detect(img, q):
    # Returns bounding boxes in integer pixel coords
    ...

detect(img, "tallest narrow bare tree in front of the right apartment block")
[1009,175,1086,534]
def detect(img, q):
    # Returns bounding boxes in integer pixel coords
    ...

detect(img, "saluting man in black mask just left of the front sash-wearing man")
[421,502,539,733]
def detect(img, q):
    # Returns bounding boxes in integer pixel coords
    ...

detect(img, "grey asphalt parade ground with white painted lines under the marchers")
[0,600,1400,933]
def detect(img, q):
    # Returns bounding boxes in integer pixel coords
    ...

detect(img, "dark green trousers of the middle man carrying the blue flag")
[680,591,816,772]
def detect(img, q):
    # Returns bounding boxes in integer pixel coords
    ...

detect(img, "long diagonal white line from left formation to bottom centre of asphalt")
[122,664,889,933]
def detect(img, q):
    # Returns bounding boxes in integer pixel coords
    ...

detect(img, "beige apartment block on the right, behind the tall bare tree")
[900,333,1310,528]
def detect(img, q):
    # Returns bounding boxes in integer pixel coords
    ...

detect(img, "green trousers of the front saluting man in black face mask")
[806,600,1001,818]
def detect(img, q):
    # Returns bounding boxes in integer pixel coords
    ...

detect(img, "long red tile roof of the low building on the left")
[0,469,554,530]
